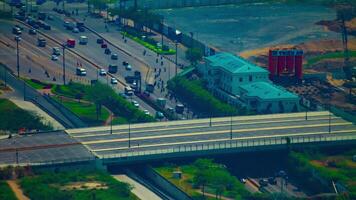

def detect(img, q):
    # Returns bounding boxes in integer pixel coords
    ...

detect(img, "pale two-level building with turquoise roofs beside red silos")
[197,53,299,113]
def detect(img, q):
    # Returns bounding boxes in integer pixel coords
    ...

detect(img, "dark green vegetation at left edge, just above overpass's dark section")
[0,99,52,132]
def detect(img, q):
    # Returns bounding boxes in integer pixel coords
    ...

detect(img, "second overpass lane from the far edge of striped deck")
[71,119,345,142]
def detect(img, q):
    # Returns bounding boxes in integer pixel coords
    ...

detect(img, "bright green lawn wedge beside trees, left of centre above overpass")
[53,97,109,125]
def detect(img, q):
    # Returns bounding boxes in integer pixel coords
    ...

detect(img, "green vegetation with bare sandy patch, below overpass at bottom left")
[20,171,138,200]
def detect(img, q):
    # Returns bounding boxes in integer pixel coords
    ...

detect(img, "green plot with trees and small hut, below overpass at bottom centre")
[155,159,254,199]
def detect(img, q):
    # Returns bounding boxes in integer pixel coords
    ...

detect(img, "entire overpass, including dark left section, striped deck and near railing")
[0,111,356,165]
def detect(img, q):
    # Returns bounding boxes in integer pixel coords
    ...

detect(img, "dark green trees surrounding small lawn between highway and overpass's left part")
[52,82,154,124]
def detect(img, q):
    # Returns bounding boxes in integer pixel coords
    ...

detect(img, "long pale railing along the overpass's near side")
[99,133,356,159]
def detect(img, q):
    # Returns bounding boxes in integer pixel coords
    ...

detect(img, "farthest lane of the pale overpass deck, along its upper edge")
[70,113,340,137]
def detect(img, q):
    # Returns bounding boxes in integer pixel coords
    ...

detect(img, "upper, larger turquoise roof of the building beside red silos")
[205,52,268,73]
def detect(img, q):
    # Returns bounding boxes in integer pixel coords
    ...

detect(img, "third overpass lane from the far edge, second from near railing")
[83,125,355,149]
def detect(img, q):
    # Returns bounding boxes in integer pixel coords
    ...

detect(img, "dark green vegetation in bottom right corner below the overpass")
[288,148,356,200]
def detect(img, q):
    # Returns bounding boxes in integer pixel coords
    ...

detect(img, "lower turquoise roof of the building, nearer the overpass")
[240,82,298,100]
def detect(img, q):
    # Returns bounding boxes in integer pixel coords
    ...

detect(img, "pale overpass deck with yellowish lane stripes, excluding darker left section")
[66,112,356,157]
